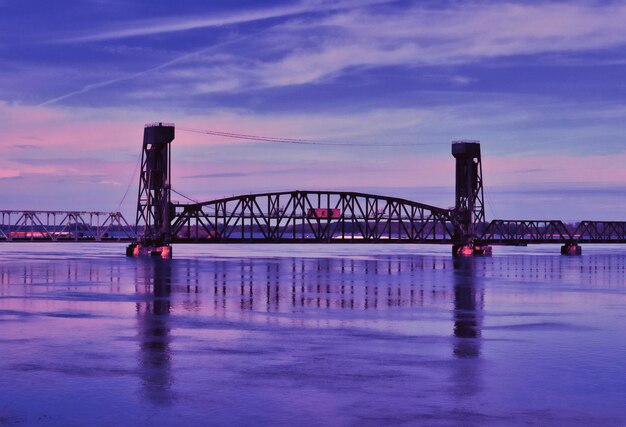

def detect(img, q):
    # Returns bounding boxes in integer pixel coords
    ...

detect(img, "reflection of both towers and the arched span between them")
[129,257,484,405]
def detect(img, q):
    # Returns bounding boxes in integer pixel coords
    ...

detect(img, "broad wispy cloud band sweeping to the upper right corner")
[149,2,626,93]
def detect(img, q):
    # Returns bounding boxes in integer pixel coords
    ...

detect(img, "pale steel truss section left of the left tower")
[0,210,138,242]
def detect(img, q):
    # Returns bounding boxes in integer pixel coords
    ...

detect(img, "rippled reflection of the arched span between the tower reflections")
[136,257,464,315]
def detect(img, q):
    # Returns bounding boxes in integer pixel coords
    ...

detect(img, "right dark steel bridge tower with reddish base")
[452,141,491,255]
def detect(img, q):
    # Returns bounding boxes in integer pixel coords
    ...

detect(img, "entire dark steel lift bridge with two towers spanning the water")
[0,123,626,257]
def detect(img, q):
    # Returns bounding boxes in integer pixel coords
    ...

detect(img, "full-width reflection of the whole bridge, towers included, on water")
[0,255,626,405]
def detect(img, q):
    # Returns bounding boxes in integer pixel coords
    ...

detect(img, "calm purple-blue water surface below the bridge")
[0,243,626,426]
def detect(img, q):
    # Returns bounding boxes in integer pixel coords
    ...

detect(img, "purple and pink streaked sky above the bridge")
[0,0,626,221]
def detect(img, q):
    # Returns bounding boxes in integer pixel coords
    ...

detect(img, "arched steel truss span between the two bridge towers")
[171,191,454,243]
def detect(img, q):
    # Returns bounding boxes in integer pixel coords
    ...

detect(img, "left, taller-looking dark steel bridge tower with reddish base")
[127,123,174,257]
